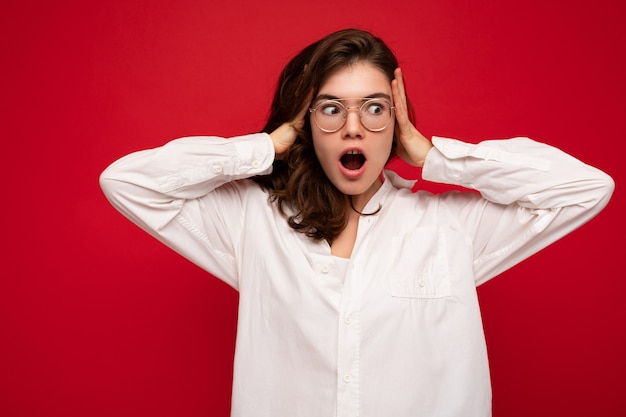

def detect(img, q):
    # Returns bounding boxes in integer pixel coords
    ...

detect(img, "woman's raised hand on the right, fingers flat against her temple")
[391,68,433,167]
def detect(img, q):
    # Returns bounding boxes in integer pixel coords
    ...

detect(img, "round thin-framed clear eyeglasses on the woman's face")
[309,98,395,133]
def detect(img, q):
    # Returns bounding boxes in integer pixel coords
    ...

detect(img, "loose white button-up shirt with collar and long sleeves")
[101,134,614,417]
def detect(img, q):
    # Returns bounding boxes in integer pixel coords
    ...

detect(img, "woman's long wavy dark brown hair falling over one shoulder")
[254,29,413,243]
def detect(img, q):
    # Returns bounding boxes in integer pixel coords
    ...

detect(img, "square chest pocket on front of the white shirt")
[388,227,452,299]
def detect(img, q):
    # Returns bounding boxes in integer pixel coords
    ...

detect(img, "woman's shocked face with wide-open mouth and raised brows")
[310,62,395,204]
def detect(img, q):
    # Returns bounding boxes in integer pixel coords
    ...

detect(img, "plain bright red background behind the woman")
[0,0,626,417]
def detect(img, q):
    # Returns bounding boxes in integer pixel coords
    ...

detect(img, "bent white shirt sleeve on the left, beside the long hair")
[100,133,274,289]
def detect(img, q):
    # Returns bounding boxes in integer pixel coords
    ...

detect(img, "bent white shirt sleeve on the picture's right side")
[422,137,615,285]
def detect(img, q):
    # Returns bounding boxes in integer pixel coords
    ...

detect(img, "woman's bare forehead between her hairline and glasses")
[319,62,391,98]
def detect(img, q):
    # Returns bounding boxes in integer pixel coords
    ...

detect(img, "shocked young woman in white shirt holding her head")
[101,30,613,417]
